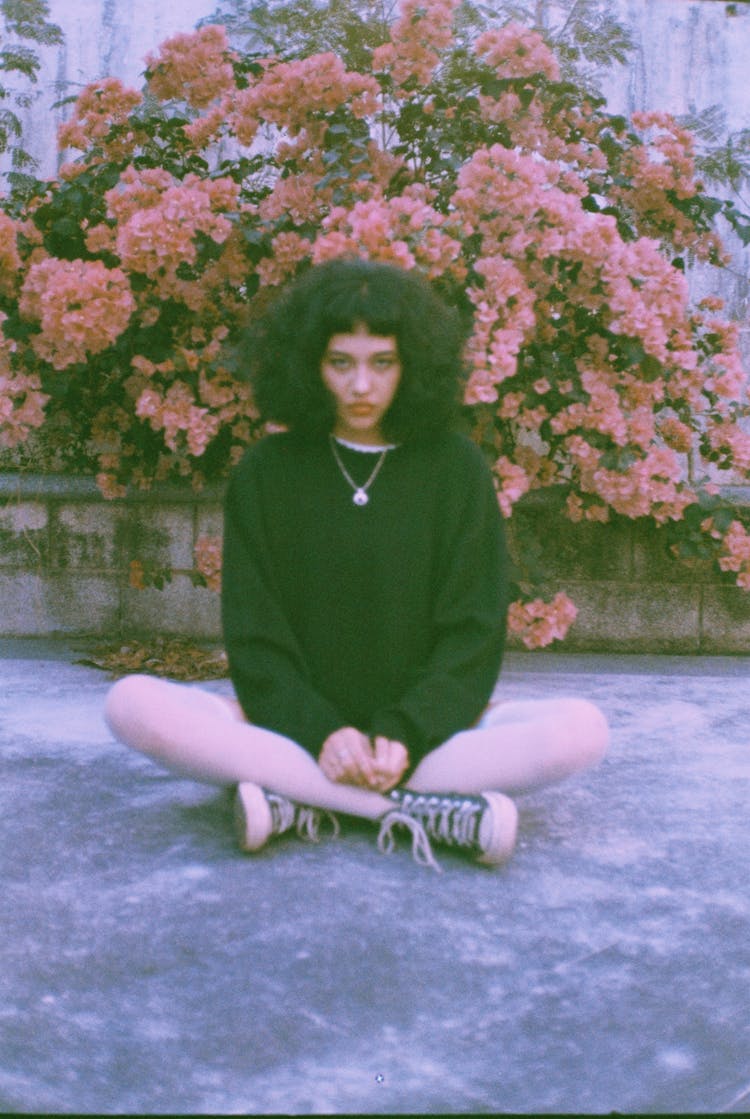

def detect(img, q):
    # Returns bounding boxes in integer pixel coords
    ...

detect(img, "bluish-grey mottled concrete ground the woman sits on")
[0,641,750,1113]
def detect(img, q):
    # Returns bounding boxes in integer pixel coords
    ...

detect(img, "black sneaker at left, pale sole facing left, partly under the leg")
[234,781,340,852]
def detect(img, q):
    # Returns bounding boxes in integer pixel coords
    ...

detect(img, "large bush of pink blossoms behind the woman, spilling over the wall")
[0,0,750,647]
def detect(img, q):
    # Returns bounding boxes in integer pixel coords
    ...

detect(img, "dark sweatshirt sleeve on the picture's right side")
[371,448,508,762]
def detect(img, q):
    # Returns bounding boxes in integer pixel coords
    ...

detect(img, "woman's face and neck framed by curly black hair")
[320,327,401,446]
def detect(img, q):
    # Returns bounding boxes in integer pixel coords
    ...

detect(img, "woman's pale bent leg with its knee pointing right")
[407,698,609,793]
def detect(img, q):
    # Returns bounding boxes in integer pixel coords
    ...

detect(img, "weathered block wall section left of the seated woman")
[0,474,222,639]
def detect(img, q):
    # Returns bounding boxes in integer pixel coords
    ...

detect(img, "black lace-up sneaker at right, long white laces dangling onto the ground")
[377,789,518,869]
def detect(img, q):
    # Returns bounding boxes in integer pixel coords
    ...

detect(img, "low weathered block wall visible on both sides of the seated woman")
[0,474,750,653]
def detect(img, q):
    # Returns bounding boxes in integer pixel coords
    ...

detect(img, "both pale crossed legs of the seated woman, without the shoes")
[105,676,609,819]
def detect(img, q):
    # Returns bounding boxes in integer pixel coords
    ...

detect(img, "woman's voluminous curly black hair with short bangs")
[240,257,465,442]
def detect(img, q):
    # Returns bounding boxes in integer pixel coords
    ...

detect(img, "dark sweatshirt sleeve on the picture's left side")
[222,452,344,756]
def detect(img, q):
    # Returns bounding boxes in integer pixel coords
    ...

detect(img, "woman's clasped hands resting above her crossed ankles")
[318,726,409,792]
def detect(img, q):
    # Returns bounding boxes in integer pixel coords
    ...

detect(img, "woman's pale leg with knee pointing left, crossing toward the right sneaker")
[105,676,393,819]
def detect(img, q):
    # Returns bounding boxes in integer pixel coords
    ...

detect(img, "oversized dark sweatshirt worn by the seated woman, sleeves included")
[222,433,507,764]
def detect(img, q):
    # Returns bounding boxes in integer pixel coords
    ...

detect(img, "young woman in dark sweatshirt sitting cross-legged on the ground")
[106,260,608,865]
